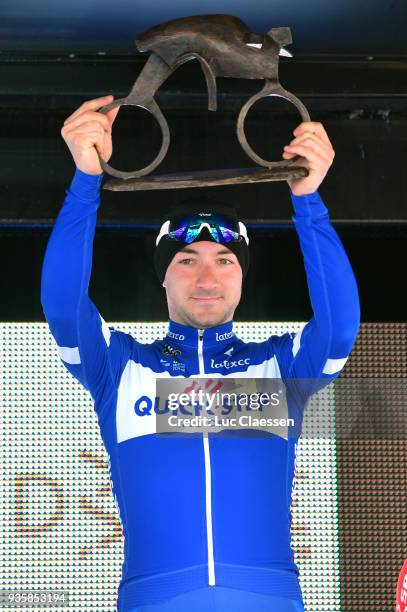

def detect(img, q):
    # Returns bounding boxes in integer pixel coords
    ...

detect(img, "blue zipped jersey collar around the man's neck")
[165,319,235,348]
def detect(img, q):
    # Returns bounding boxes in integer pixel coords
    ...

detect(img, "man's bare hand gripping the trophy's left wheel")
[61,95,120,174]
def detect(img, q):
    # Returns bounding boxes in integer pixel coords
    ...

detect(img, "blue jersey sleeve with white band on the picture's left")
[41,169,130,413]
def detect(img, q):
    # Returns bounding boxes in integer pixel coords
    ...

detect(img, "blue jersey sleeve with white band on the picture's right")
[275,191,360,393]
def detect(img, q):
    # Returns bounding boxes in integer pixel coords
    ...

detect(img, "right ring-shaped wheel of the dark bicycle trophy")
[236,81,310,168]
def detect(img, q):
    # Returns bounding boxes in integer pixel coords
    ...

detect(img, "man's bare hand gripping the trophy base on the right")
[283,121,335,195]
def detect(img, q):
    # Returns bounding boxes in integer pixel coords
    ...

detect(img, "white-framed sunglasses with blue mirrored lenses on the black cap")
[156,213,249,245]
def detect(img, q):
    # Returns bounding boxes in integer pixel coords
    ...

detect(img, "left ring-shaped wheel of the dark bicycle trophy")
[97,93,170,179]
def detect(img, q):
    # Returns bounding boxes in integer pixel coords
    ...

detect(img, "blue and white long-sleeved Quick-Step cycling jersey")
[41,169,360,612]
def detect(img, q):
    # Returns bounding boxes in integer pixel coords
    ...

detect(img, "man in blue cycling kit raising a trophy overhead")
[41,96,360,612]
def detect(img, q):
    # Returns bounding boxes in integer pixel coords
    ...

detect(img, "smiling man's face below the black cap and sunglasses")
[163,240,242,329]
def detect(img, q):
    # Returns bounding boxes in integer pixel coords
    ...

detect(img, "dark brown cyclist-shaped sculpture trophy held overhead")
[98,14,310,191]
